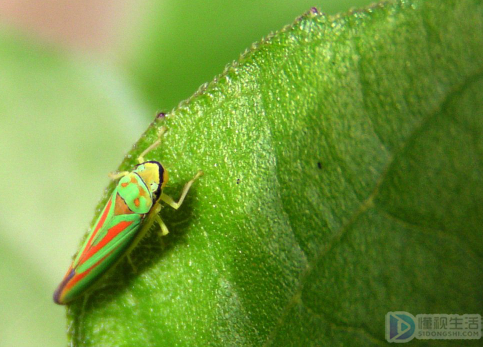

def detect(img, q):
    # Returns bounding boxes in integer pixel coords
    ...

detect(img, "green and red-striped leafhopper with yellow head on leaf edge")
[54,126,203,305]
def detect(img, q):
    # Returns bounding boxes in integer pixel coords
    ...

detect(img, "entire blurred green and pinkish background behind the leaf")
[0,0,371,346]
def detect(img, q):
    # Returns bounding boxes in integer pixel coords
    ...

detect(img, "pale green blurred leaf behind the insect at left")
[0,25,147,346]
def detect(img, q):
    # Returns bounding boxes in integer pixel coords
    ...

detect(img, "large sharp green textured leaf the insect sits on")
[68,0,483,346]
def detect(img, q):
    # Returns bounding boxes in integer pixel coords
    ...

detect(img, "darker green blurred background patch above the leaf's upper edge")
[120,0,372,110]
